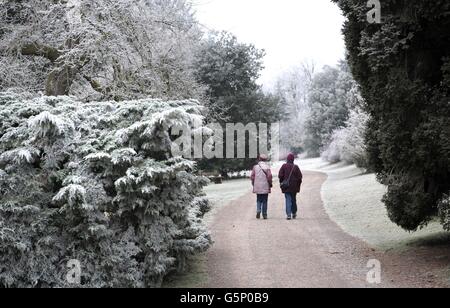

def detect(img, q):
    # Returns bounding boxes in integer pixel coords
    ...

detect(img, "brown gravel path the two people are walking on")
[207,172,448,288]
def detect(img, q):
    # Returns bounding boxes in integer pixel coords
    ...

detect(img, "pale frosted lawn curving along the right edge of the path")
[298,158,448,250]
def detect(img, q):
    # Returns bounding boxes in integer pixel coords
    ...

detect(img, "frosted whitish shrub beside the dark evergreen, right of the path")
[322,109,369,167]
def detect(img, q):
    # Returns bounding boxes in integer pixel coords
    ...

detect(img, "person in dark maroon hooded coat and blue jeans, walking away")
[278,154,303,220]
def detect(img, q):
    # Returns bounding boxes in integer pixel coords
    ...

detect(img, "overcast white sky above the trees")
[193,0,345,87]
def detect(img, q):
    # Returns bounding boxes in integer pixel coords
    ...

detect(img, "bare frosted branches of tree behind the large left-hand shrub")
[0,0,203,101]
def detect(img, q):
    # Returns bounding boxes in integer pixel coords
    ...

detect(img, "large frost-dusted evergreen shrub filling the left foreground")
[0,93,211,287]
